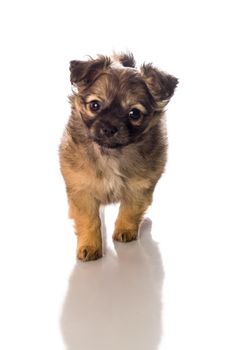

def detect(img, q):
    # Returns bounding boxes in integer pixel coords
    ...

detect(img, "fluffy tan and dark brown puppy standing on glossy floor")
[59,54,178,261]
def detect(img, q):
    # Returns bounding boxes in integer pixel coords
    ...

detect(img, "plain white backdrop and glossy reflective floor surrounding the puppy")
[0,0,233,350]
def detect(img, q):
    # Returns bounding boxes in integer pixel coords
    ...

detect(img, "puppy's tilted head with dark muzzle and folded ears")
[70,54,178,148]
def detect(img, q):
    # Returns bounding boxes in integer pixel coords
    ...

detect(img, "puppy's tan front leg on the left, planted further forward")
[69,192,102,261]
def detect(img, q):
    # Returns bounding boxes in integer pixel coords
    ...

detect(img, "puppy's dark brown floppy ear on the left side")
[70,56,111,85]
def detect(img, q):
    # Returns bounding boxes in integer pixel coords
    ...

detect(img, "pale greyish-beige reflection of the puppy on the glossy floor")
[61,219,163,350]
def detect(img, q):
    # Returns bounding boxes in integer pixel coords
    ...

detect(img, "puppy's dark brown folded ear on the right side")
[141,64,178,108]
